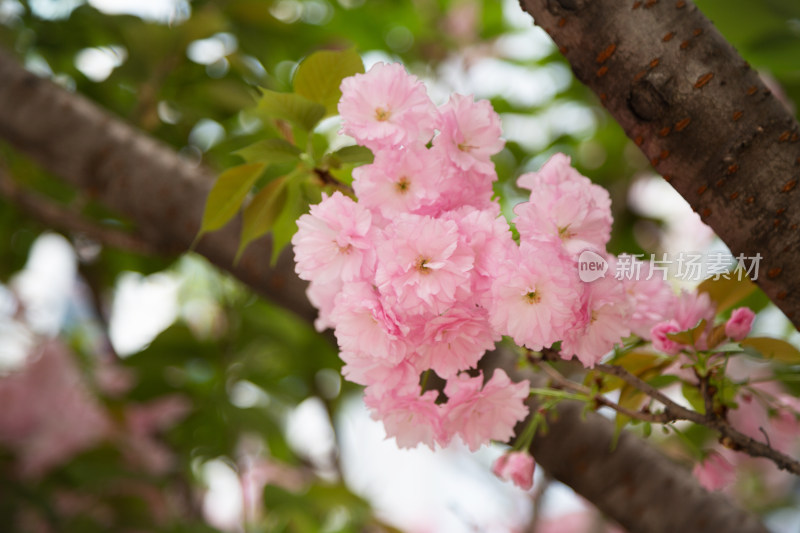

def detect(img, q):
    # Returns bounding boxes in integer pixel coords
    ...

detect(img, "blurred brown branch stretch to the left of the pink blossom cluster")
[0,50,316,319]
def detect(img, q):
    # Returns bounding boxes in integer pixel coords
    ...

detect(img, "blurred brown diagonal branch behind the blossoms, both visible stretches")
[0,44,776,533]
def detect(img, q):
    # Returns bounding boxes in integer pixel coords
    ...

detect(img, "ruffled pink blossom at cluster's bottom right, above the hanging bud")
[444,369,530,451]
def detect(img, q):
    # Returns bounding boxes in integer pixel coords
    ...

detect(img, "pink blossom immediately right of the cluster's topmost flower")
[433,94,505,175]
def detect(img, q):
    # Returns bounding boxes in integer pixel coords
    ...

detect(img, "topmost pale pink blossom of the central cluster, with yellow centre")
[339,63,438,149]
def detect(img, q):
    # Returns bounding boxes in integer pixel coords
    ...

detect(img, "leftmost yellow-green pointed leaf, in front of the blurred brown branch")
[197,163,266,238]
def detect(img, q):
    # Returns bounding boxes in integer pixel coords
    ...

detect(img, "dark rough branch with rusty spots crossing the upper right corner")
[521,0,800,326]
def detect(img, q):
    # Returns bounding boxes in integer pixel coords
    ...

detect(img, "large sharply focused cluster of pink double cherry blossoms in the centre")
[292,63,713,458]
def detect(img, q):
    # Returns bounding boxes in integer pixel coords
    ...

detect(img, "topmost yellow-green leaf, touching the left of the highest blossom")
[293,48,364,115]
